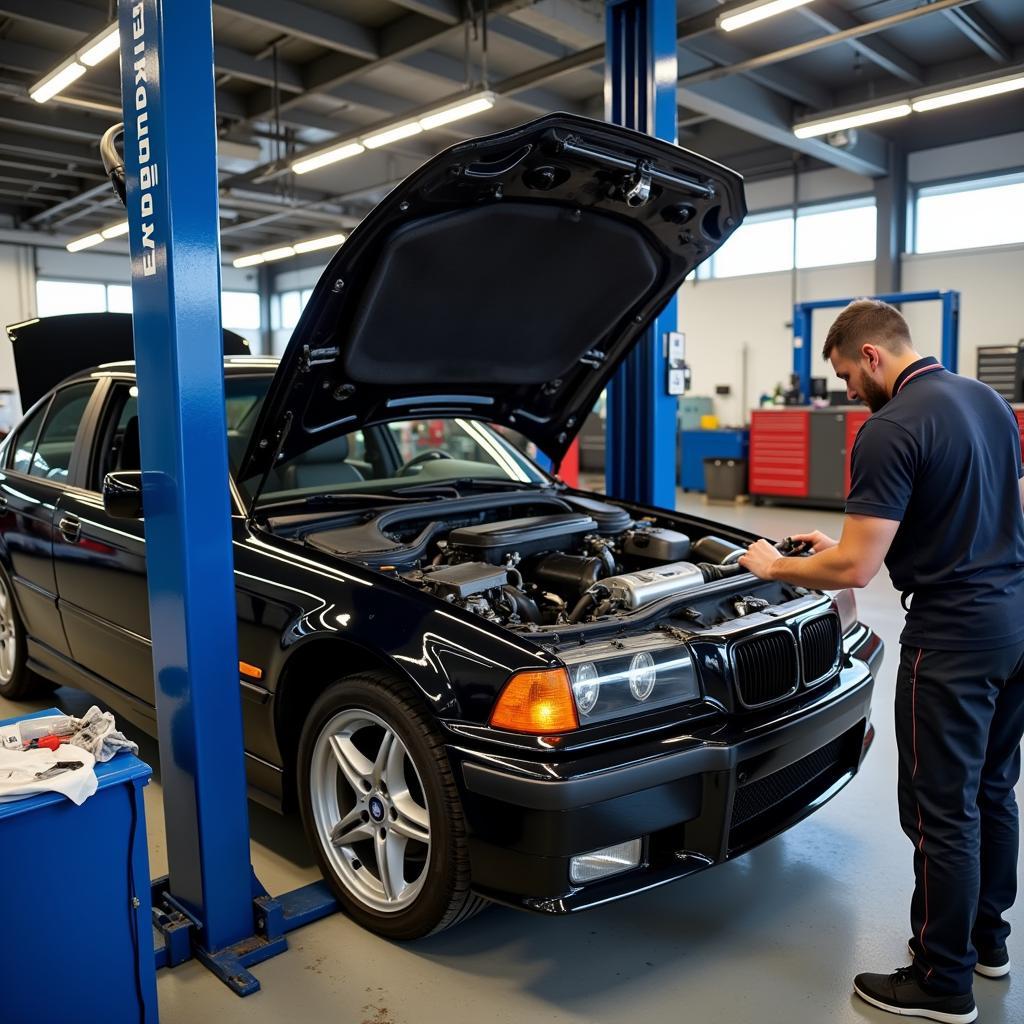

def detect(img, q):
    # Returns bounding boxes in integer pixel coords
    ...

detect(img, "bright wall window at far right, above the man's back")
[913,174,1024,253]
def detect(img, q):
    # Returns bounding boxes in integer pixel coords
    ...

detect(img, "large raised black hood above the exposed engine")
[240,114,745,479]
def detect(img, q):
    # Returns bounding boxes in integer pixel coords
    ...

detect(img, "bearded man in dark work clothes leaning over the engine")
[740,299,1024,1024]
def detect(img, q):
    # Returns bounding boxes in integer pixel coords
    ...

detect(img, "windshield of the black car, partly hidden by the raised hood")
[225,378,549,505]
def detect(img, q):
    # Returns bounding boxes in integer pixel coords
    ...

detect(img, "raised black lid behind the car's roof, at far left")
[7,313,249,412]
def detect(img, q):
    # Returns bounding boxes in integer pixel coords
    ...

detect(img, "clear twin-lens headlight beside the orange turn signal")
[559,636,700,725]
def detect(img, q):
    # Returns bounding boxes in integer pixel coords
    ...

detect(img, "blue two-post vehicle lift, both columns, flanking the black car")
[118,0,676,995]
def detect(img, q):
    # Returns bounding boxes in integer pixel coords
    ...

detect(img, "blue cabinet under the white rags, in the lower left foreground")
[0,710,157,1024]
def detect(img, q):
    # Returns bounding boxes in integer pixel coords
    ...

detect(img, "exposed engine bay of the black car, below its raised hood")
[284,490,792,631]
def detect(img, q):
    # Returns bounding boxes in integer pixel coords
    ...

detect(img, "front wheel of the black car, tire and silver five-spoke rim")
[298,673,486,939]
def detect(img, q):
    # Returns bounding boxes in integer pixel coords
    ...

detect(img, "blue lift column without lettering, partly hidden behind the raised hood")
[604,0,678,508]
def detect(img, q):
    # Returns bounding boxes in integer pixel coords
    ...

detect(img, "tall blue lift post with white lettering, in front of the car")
[119,0,258,958]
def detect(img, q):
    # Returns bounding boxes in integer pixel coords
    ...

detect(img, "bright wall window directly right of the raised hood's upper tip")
[696,198,877,279]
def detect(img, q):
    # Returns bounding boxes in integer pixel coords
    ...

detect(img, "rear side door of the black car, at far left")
[0,380,96,655]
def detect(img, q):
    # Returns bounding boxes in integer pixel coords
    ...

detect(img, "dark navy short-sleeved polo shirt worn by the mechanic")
[846,358,1024,650]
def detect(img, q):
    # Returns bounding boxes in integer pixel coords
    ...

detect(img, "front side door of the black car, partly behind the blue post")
[53,377,155,706]
